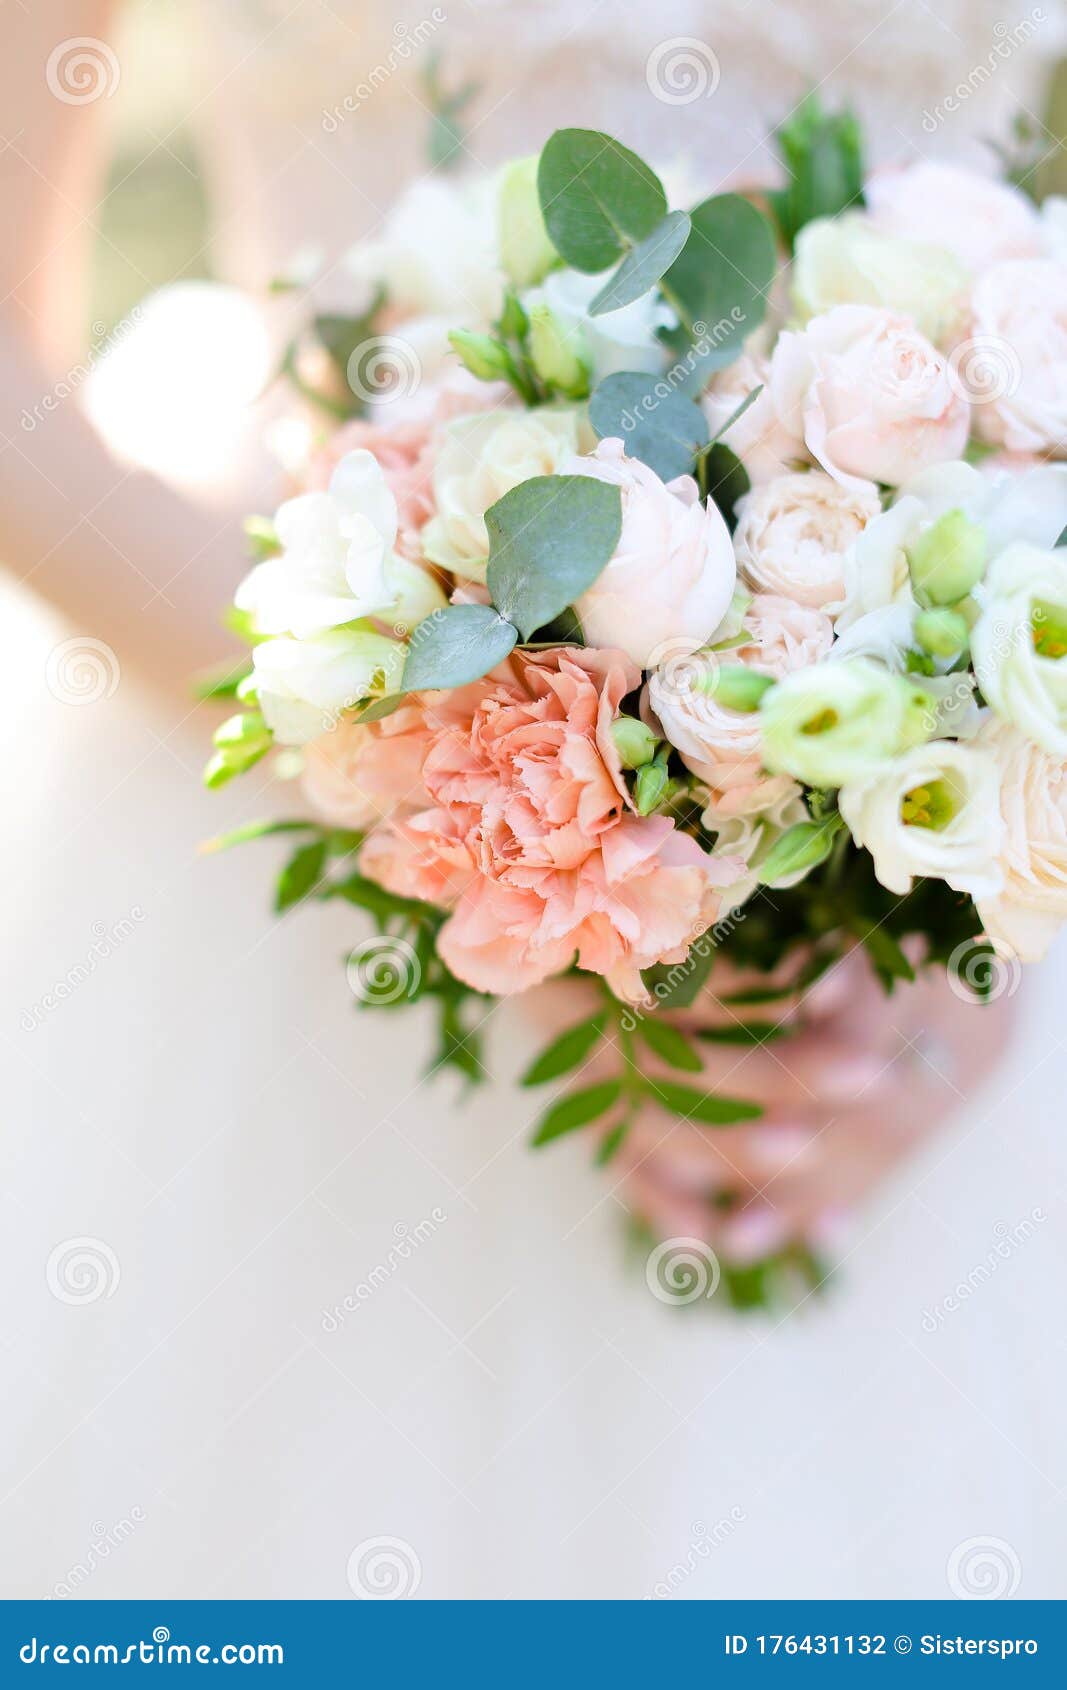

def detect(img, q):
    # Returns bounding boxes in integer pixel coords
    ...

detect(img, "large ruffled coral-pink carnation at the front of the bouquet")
[362,649,739,997]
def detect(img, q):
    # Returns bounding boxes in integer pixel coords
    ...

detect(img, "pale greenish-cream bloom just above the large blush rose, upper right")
[793,211,971,346]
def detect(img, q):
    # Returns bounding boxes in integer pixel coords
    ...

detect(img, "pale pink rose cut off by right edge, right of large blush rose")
[954,259,1067,458]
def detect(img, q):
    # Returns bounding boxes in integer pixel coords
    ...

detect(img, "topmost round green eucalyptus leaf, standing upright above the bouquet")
[538,128,666,274]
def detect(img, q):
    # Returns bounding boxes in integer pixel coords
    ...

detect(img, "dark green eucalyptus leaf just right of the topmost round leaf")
[663,194,776,372]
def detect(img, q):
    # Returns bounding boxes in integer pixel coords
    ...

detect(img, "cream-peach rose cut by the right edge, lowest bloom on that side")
[976,718,1067,962]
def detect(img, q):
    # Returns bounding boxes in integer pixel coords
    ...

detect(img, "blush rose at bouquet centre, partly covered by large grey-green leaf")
[571,439,737,669]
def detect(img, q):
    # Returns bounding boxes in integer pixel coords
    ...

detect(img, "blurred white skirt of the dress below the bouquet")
[0,597,1067,1597]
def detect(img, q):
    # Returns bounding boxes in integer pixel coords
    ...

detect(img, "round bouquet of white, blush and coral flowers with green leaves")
[206,100,1067,1304]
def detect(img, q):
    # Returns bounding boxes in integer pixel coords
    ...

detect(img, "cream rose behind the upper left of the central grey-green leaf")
[421,406,583,581]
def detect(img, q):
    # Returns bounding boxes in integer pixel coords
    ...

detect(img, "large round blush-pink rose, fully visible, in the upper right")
[771,306,971,487]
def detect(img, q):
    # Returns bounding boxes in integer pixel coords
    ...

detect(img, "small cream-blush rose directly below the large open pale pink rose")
[734,470,881,610]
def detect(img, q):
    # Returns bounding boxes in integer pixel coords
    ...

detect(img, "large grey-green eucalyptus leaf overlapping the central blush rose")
[486,475,622,638]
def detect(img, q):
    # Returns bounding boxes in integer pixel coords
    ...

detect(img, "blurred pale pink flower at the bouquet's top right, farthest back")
[864,162,1042,272]
